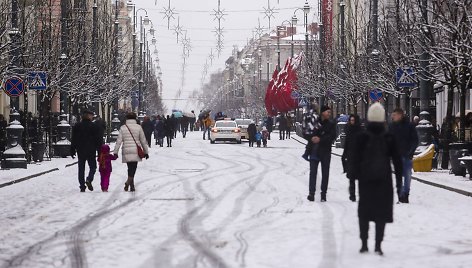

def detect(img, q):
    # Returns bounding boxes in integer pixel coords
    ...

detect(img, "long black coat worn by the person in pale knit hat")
[348,123,402,222]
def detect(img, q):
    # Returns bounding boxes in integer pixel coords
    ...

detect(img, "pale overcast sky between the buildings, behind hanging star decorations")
[138,0,318,111]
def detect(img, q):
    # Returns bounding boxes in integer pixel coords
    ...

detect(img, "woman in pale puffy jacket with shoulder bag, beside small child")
[113,112,149,192]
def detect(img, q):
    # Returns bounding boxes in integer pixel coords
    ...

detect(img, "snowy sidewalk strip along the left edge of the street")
[0,157,77,188]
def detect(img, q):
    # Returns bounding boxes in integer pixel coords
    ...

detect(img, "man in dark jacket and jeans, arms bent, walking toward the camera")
[307,106,336,202]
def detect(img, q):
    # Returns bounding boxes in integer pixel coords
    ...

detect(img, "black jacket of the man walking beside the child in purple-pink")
[71,119,103,158]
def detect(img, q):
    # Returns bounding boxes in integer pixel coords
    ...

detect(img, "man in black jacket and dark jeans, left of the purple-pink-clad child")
[71,110,103,192]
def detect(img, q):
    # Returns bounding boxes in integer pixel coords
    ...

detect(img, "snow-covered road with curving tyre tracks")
[0,133,472,268]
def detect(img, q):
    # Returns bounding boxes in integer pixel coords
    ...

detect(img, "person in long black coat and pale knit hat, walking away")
[348,102,402,255]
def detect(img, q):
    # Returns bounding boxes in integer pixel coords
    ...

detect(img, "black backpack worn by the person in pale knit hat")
[360,133,391,181]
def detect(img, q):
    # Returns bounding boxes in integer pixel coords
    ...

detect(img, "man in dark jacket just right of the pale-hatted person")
[389,108,419,203]
